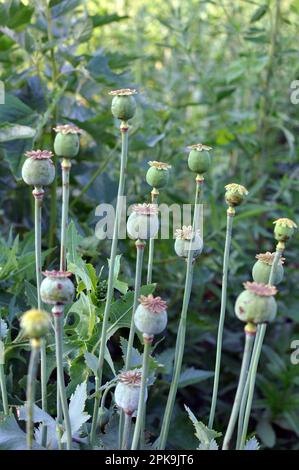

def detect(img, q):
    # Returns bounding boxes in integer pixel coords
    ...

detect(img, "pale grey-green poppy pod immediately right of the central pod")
[174,225,203,259]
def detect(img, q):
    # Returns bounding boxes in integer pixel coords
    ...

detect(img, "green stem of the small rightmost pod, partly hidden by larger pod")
[237,250,284,449]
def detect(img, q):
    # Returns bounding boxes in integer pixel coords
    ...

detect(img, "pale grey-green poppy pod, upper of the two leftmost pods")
[22,150,55,187]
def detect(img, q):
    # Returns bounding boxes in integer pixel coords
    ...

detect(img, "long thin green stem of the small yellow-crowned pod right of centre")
[209,207,235,429]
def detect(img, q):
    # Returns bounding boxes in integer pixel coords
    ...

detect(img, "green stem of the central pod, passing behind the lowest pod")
[119,240,145,448]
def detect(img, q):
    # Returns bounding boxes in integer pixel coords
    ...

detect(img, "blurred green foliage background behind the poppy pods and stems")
[0,0,299,449]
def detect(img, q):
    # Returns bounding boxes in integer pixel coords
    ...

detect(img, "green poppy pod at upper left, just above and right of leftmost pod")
[54,124,82,158]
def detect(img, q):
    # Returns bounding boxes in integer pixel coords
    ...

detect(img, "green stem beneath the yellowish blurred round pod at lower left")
[26,340,39,450]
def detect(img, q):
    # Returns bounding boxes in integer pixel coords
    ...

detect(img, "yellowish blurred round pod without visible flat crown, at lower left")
[20,309,50,339]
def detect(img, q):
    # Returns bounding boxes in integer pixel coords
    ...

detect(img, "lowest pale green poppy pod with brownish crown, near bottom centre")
[114,369,147,416]
